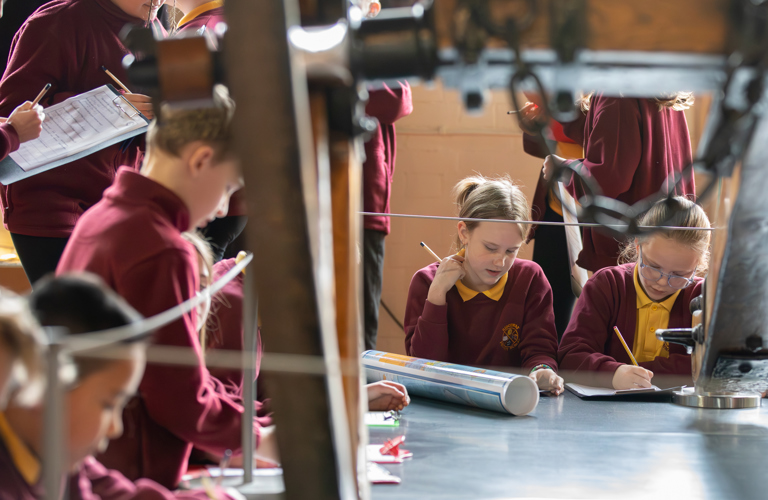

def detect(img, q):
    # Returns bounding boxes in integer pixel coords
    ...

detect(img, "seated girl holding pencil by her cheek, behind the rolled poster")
[405,176,563,394]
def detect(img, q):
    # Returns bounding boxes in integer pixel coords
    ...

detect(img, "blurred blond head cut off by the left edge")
[0,288,45,410]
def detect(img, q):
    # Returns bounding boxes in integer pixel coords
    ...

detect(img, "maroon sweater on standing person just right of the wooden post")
[363,82,413,234]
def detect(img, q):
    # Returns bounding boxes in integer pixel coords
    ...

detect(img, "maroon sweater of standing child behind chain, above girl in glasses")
[564,94,696,272]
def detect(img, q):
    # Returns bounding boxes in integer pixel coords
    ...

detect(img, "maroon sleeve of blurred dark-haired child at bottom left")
[76,457,231,500]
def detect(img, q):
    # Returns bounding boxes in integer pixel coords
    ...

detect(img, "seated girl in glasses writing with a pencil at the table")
[558,196,710,389]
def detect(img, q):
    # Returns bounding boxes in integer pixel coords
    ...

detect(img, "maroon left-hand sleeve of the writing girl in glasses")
[558,273,623,373]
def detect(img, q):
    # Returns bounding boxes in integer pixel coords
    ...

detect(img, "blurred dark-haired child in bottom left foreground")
[0,276,243,500]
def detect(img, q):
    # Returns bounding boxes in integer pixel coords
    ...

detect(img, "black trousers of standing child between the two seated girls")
[533,205,576,341]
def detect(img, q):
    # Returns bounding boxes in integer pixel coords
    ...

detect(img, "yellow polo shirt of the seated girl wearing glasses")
[632,265,681,363]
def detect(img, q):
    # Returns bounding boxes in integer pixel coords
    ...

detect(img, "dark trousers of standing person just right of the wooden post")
[363,229,386,350]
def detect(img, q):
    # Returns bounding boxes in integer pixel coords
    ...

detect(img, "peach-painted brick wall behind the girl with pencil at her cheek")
[378,83,708,354]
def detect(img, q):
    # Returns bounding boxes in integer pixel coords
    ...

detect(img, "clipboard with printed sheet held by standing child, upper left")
[0,85,149,185]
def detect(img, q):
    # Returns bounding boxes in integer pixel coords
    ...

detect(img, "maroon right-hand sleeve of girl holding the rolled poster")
[520,269,557,371]
